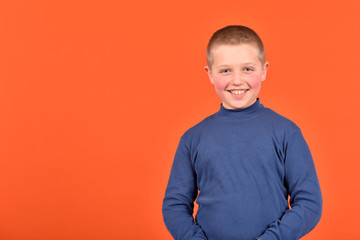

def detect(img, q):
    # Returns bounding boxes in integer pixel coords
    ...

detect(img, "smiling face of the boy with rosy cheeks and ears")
[205,44,269,109]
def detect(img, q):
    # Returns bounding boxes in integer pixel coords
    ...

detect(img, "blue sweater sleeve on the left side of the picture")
[162,137,207,240]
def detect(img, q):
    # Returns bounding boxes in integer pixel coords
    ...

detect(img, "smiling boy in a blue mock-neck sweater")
[163,26,322,240]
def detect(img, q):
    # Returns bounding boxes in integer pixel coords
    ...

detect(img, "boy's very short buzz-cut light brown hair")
[206,25,265,68]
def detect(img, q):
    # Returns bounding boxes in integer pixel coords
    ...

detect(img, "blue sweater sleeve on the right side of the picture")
[258,128,322,240]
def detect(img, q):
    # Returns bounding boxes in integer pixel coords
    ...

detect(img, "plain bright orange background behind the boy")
[0,0,360,240]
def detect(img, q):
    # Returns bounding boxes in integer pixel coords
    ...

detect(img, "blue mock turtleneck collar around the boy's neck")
[216,98,267,120]
